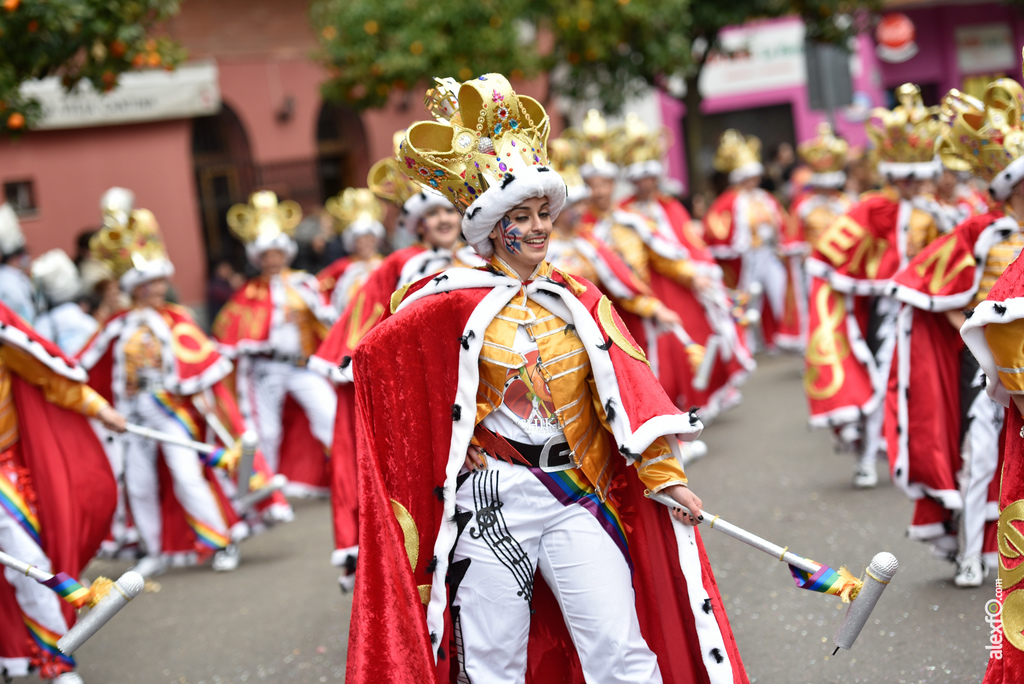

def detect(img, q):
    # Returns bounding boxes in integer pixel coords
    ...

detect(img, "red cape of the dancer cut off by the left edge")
[0,304,118,658]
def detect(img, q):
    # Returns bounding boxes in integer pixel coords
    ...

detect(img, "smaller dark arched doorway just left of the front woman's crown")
[316,102,370,202]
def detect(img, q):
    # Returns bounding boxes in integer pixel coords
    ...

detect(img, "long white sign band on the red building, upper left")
[22,61,220,130]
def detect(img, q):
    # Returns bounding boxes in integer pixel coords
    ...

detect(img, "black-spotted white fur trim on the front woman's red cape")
[387,268,708,672]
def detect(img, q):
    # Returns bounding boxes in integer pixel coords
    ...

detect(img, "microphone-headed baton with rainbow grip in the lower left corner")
[0,551,144,655]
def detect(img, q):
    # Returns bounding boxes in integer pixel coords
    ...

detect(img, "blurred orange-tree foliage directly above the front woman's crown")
[311,0,541,109]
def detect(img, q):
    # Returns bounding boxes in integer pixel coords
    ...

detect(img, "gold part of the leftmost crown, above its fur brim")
[89,209,167,277]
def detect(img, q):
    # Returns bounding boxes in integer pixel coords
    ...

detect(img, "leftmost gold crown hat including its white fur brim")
[89,201,174,292]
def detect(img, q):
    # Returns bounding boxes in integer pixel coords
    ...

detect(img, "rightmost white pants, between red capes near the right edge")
[958,370,1003,561]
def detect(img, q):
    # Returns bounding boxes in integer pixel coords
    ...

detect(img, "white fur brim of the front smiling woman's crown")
[462,166,567,257]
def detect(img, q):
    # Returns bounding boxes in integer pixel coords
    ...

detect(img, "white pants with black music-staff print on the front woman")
[450,458,662,684]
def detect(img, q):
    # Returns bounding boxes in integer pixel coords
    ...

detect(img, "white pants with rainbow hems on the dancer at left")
[123,392,229,556]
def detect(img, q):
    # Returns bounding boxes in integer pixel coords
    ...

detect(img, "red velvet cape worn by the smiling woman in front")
[346,269,748,684]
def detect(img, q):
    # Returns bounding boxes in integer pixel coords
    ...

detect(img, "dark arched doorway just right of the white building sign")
[193,104,256,271]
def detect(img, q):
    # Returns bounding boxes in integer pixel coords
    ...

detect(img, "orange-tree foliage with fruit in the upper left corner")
[0,0,184,135]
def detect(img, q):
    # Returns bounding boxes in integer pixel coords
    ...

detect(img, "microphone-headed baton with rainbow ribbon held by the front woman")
[650,494,899,655]
